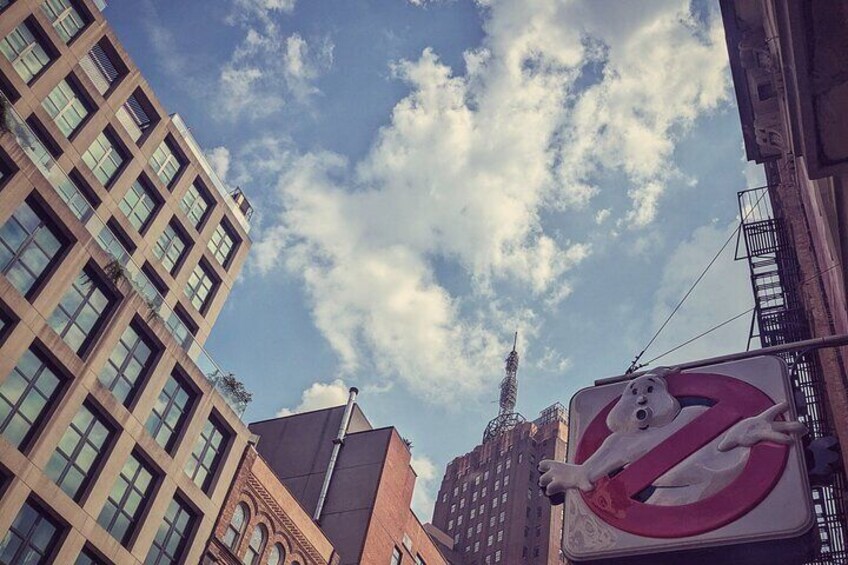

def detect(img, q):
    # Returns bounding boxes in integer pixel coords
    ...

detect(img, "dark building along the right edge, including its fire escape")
[721,0,848,564]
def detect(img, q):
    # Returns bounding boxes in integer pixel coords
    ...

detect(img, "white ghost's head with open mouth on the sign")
[607,373,680,432]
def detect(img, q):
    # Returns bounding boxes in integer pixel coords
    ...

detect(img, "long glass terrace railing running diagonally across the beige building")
[0,92,247,417]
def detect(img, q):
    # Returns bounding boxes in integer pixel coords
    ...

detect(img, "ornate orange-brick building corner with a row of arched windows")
[204,446,339,565]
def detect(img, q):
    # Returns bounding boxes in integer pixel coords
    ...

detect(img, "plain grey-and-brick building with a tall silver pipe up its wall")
[250,389,446,565]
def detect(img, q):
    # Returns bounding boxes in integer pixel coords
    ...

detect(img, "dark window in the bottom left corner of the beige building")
[0,501,60,565]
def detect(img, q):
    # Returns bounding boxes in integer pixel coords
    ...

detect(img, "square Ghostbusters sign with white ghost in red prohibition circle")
[539,357,812,561]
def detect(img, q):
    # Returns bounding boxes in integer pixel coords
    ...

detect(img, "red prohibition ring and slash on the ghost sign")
[575,373,789,538]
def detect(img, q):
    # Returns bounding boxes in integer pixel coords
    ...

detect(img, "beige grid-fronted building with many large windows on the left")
[0,0,255,564]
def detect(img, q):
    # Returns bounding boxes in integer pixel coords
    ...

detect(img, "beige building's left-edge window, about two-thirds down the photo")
[0,349,62,447]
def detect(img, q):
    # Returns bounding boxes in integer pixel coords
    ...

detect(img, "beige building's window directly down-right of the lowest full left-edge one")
[45,404,111,501]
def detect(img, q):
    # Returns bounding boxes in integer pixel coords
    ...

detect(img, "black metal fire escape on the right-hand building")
[737,183,848,565]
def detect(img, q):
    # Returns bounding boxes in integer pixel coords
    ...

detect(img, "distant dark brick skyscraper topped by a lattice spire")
[433,340,568,565]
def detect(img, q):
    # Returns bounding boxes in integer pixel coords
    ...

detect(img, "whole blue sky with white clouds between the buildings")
[105,0,762,520]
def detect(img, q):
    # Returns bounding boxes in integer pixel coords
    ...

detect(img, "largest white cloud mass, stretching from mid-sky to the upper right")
[254,0,727,403]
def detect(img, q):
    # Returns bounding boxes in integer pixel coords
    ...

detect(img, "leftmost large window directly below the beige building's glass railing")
[0,198,63,296]
